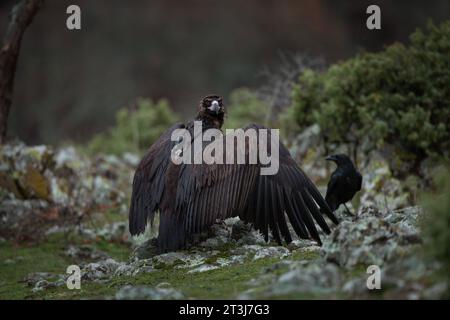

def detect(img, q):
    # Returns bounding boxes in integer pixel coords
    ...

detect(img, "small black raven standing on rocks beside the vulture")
[325,154,362,215]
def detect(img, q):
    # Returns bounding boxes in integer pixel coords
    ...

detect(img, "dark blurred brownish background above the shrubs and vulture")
[0,0,450,144]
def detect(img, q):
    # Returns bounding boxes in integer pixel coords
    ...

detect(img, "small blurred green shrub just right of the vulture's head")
[224,88,270,129]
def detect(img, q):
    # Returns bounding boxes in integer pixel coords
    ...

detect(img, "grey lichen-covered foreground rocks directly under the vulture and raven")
[7,207,446,299]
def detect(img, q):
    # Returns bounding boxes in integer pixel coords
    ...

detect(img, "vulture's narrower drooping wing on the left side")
[129,123,184,235]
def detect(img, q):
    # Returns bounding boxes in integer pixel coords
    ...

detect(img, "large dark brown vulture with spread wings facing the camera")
[129,95,338,252]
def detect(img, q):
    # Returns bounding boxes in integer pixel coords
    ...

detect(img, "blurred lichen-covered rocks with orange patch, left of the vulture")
[0,143,136,241]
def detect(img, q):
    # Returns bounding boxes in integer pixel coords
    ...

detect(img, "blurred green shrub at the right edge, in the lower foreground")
[421,169,450,298]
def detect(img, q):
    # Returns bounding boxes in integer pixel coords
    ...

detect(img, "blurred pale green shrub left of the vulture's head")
[87,98,177,155]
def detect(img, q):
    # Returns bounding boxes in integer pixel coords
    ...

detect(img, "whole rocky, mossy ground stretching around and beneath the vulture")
[0,139,448,299]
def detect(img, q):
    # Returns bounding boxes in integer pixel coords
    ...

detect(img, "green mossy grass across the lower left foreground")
[0,235,324,299]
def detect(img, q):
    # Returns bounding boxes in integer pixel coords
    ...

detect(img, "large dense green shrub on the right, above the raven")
[285,21,450,168]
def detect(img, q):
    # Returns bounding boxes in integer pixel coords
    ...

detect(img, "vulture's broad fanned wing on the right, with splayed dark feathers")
[160,125,338,249]
